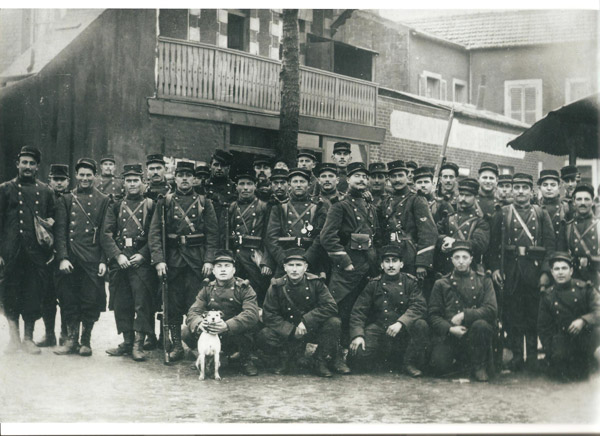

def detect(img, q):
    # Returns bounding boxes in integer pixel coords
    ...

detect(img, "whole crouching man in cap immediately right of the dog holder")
[256,248,350,377]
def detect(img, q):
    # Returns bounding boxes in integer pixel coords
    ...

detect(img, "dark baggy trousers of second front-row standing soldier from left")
[57,261,106,323]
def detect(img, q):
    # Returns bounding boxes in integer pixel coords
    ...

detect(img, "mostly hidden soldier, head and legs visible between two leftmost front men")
[35,164,70,347]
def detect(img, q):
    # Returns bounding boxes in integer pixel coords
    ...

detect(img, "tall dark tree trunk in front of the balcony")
[277,9,300,167]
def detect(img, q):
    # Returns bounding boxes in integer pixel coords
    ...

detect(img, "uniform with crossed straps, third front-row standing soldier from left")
[103,195,158,334]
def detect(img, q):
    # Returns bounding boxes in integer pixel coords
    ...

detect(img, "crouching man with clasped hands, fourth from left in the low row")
[429,241,498,381]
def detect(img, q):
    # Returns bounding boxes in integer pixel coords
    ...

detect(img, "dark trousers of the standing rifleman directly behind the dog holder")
[167,266,202,325]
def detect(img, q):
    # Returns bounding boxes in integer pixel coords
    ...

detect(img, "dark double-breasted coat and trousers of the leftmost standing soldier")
[0,178,55,321]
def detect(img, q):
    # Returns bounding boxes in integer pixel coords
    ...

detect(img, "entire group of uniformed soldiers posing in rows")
[0,142,600,381]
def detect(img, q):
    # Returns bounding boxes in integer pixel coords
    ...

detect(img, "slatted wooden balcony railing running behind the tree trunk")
[157,37,377,126]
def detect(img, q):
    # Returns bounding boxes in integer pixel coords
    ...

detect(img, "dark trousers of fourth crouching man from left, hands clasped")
[429,319,494,375]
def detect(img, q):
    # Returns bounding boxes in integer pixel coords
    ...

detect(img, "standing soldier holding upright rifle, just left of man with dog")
[148,161,219,361]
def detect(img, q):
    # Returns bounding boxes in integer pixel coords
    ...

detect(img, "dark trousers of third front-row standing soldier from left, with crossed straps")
[110,264,156,334]
